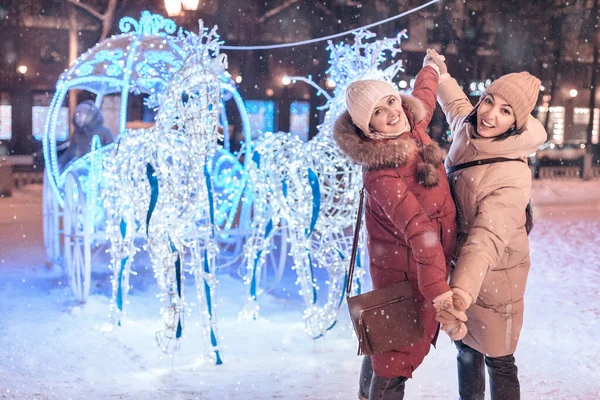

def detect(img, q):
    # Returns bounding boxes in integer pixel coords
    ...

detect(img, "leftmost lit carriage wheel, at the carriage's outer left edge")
[42,173,62,265]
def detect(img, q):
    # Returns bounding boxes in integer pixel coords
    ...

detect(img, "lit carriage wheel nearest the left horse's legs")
[63,174,91,303]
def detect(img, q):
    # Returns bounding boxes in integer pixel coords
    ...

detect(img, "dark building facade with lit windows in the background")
[0,0,600,154]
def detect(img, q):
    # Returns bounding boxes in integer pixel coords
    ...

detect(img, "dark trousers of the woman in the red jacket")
[358,356,408,400]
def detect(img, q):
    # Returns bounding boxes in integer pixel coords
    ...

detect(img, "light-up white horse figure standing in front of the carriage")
[104,25,227,364]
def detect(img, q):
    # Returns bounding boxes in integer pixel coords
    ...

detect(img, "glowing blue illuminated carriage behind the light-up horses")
[42,11,252,302]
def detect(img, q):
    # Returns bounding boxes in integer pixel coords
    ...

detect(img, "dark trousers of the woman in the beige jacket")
[454,341,521,400]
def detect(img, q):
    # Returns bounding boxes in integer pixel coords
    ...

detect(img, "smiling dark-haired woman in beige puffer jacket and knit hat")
[426,54,547,400]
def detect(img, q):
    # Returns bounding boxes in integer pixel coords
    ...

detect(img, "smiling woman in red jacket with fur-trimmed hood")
[333,50,466,400]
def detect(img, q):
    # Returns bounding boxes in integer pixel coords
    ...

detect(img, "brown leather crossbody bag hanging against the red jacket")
[346,188,424,355]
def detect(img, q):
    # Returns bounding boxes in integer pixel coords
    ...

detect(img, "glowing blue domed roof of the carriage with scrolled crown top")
[41,11,184,207]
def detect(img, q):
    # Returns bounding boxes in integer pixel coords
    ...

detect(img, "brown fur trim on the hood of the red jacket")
[333,95,443,187]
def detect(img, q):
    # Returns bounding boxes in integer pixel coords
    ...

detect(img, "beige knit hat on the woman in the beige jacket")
[480,72,541,129]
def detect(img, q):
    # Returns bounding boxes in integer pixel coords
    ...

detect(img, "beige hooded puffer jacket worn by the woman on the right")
[438,74,547,357]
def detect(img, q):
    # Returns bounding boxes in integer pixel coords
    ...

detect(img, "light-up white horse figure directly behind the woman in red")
[245,31,405,338]
